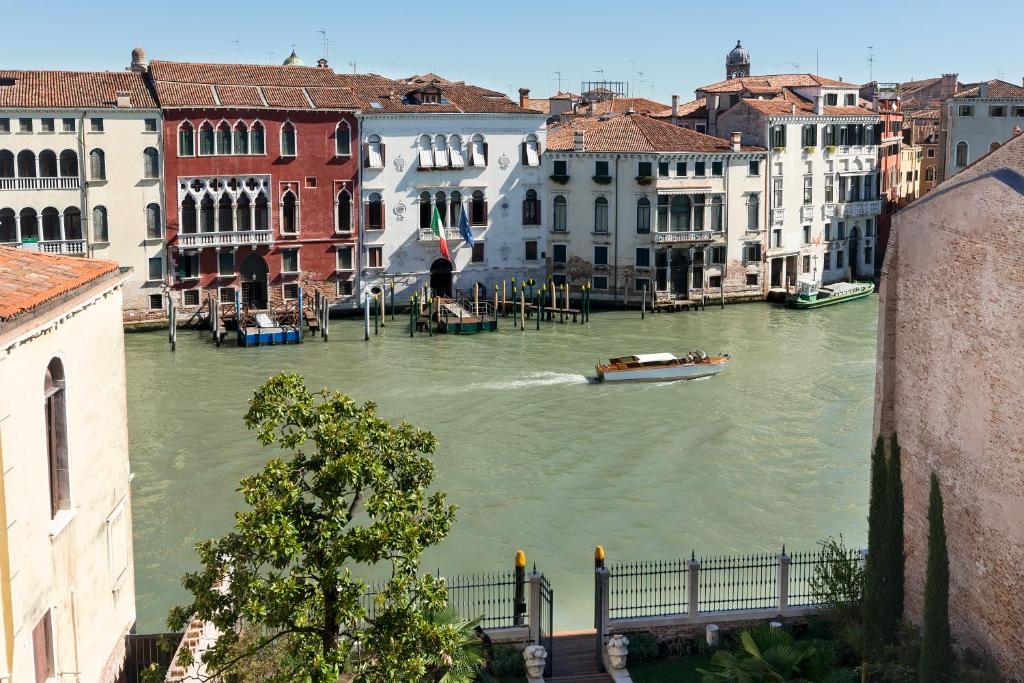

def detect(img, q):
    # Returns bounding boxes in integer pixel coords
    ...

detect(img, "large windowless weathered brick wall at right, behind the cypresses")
[874,132,1024,679]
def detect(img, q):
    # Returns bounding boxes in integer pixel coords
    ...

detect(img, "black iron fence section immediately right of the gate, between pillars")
[608,559,688,618]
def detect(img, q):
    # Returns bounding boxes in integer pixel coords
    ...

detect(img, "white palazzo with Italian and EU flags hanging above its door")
[338,74,546,300]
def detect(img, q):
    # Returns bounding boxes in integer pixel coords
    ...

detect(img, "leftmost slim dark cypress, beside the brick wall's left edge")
[864,434,893,661]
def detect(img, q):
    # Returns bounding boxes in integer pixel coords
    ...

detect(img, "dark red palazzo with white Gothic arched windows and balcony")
[150,61,358,308]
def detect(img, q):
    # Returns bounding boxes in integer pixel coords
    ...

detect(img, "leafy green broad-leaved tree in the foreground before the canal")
[168,373,463,683]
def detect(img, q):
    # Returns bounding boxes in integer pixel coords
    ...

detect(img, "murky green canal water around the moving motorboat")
[126,297,878,632]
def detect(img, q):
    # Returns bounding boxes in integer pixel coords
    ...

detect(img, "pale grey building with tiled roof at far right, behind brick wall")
[938,80,1024,181]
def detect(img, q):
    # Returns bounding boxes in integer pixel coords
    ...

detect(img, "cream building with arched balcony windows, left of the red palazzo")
[0,50,165,321]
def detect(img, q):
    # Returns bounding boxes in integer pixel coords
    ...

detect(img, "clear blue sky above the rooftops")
[0,0,1024,102]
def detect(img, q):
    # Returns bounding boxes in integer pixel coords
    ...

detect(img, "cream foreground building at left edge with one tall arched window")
[0,246,135,683]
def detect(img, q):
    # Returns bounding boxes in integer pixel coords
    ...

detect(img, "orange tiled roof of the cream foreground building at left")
[0,247,118,322]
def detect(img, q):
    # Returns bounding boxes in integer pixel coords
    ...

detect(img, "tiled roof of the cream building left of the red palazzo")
[0,70,157,109]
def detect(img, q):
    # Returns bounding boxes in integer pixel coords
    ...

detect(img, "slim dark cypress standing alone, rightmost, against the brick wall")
[918,472,952,683]
